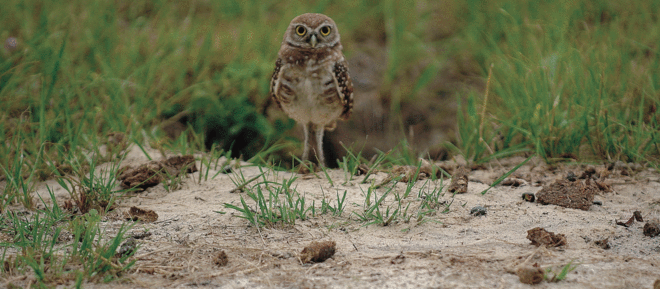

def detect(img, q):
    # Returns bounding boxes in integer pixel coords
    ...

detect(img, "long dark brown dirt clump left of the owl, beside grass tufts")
[117,155,197,189]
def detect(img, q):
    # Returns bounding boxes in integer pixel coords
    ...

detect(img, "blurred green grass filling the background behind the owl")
[0,0,660,194]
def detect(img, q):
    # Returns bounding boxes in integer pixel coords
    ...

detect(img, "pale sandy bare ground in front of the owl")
[9,145,660,288]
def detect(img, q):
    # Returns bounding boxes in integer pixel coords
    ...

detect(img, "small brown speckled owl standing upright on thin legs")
[270,13,353,166]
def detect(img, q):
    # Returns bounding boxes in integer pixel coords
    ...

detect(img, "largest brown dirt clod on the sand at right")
[536,180,598,211]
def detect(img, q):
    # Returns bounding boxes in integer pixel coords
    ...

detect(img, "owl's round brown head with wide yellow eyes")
[284,13,339,49]
